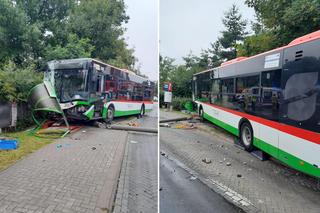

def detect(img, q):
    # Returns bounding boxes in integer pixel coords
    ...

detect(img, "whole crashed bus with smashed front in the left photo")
[44,58,155,122]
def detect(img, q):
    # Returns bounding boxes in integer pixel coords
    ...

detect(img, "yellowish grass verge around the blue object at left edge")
[0,131,54,171]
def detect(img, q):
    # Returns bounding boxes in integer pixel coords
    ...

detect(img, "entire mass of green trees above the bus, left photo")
[0,0,136,70]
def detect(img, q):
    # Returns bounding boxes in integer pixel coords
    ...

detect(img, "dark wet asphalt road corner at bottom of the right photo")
[160,152,242,213]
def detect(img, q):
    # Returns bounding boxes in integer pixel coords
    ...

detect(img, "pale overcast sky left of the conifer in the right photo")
[159,0,254,64]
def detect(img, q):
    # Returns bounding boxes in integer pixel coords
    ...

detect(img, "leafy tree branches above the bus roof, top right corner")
[246,0,320,48]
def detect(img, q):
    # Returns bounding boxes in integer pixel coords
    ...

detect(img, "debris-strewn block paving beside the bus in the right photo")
[160,112,320,213]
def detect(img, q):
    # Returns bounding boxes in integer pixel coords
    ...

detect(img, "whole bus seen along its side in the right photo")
[193,31,320,178]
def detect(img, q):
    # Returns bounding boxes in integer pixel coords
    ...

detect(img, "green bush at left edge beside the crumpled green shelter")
[0,62,43,102]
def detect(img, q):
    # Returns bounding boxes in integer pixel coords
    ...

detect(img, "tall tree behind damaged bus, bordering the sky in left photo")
[69,0,135,68]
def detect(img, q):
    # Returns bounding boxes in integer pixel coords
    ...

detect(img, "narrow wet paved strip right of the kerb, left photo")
[114,133,158,213]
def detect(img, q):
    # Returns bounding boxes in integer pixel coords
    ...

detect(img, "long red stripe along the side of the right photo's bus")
[201,102,320,144]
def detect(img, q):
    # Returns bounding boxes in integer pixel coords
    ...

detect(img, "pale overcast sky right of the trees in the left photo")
[125,0,159,80]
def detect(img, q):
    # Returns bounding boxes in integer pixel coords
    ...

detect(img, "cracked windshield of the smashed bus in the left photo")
[54,69,89,103]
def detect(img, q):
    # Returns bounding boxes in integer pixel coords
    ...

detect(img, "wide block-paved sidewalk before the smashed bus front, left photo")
[0,128,127,213]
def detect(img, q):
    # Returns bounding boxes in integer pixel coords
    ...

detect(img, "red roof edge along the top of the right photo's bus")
[194,30,320,75]
